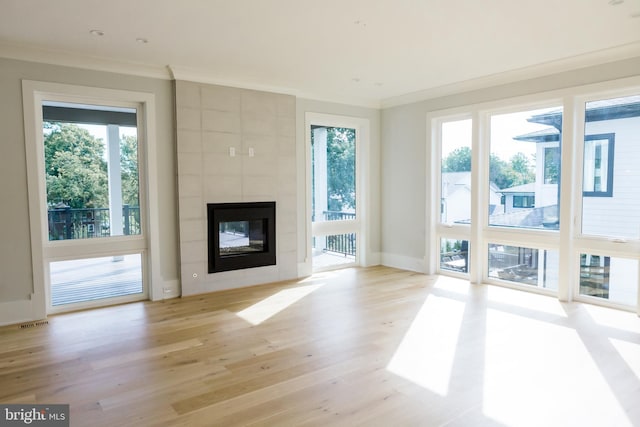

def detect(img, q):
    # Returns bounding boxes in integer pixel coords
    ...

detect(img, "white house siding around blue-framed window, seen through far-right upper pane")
[580,117,640,239]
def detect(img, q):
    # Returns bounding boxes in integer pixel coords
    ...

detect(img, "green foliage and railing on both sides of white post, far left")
[43,122,141,240]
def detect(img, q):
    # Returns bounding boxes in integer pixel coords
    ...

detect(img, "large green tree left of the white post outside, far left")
[44,123,108,208]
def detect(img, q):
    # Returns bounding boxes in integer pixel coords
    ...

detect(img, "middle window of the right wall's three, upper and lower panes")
[483,105,563,294]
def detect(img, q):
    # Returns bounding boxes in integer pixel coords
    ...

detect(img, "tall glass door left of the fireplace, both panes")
[42,101,146,312]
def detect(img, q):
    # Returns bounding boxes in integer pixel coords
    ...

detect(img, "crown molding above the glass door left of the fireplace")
[0,42,171,80]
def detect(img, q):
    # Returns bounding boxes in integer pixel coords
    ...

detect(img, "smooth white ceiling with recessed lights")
[0,0,640,106]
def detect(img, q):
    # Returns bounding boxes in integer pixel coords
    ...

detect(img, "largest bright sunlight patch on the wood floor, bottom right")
[482,309,631,426]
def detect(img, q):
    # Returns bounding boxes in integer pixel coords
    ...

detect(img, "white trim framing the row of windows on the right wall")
[425,77,640,315]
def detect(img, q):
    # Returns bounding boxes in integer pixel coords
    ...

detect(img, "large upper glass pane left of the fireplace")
[43,111,141,240]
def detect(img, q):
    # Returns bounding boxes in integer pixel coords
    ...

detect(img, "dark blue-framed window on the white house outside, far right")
[582,133,614,197]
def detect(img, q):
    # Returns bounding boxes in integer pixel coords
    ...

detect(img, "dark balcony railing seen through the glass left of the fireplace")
[48,205,140,240]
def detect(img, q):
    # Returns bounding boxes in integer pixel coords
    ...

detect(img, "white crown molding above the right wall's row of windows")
[380,42,640,108]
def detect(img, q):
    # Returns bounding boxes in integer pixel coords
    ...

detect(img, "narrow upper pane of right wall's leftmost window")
[440,119,471,224]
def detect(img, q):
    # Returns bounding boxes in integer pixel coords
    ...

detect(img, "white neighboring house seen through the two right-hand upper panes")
[490,96,640,238]
